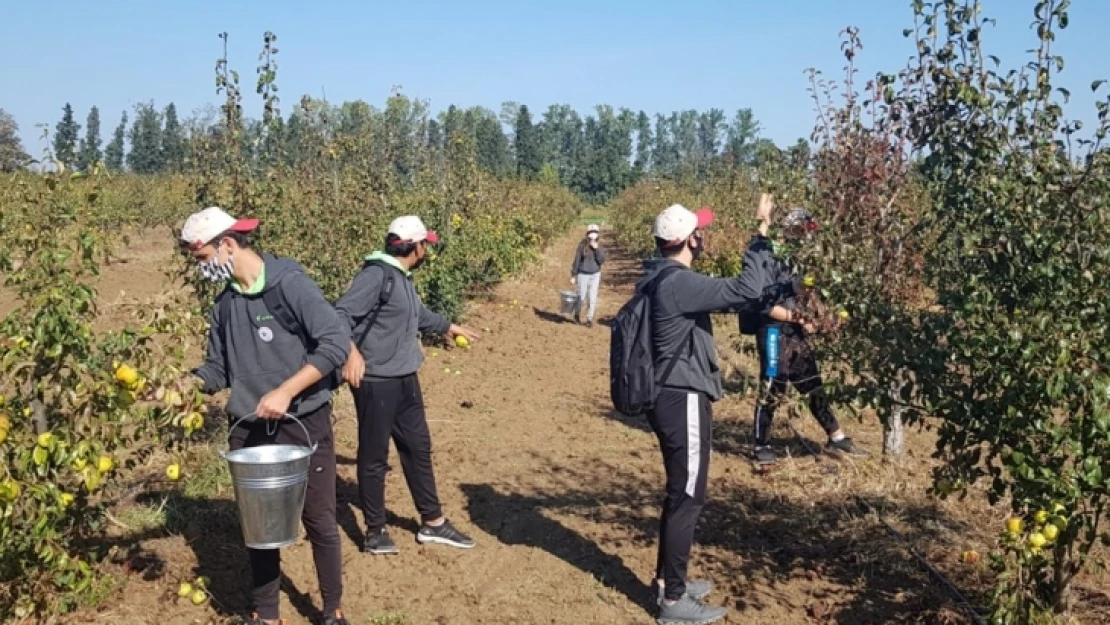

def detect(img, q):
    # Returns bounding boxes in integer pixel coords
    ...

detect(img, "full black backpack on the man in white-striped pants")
[609,266,696,416]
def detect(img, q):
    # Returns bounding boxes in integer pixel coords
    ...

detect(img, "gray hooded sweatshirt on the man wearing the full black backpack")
[636,259,794,401]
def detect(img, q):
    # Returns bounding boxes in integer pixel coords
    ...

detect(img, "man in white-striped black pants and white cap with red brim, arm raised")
[636,204,795,624]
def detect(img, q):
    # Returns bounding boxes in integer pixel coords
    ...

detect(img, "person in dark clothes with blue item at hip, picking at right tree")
[740,193,866,464]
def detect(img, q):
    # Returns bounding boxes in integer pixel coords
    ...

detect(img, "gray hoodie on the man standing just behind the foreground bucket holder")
[335,252,451,381]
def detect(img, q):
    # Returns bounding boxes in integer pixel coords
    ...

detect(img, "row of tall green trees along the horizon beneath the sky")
[0,97,809,202]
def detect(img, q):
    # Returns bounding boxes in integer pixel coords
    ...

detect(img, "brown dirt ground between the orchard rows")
[54,226,1110,625]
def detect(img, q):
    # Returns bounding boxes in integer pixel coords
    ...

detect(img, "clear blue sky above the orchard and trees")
[0,0,1110,157]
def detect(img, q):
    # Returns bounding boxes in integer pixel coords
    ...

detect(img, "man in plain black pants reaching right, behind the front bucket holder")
[335,215,478,554]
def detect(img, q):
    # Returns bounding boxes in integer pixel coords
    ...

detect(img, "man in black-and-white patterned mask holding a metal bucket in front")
[181,206,351,625]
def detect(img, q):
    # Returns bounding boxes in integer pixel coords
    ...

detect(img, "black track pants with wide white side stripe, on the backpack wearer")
[647,390,713,599]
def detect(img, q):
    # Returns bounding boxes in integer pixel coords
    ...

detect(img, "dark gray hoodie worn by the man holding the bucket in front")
[193,254,351,422]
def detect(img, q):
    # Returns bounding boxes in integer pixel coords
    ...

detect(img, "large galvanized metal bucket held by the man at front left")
[220,415,316,550]
